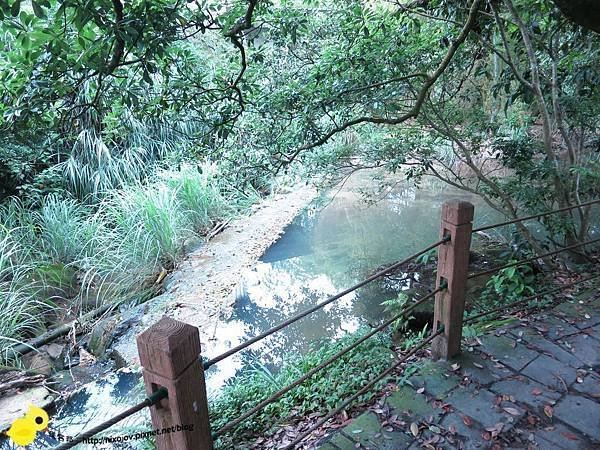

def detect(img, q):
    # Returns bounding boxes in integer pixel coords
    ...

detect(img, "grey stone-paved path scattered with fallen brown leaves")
[319,290,600,450]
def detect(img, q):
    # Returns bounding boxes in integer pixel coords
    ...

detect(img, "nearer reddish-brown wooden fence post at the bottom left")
[137,317,213,450]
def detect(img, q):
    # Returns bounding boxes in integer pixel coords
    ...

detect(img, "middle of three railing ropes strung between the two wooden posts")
[213,287,445,438]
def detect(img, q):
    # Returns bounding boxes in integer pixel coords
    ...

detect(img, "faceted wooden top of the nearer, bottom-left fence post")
[136,316,200,379]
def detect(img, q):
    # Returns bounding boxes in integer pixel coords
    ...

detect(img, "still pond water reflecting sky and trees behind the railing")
[0,172,499,450]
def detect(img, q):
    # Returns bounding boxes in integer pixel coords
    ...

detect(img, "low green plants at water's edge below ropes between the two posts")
[210,330,398,448]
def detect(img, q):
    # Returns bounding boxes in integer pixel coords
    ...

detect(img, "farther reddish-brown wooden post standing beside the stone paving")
[431,201,474,359]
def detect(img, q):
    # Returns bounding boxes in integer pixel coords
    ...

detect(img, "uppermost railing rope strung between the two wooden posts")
[203,236,450,370]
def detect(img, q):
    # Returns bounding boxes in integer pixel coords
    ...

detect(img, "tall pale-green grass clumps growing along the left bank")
[0,156,256,355]
